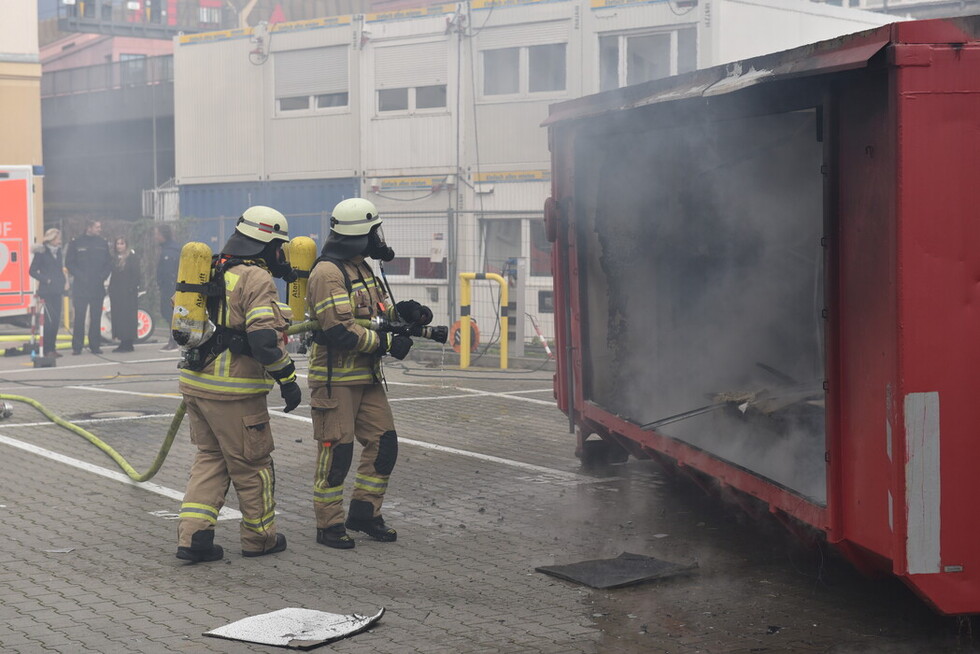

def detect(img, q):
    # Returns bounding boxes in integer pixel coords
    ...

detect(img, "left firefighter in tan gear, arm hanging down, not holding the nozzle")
[177,206,302,563]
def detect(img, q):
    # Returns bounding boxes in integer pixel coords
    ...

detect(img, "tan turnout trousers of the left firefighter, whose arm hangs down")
[177,394,276,552]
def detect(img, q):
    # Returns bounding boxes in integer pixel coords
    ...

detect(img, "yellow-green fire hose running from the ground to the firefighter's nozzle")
[0,319,448,482]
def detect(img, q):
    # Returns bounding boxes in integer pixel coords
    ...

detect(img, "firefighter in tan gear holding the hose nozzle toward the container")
[306,198,432,549]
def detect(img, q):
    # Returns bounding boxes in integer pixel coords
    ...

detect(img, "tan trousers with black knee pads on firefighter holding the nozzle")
[310,384,398,528]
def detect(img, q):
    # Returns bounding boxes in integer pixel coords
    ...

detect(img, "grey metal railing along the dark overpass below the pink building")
[41,55,174,98]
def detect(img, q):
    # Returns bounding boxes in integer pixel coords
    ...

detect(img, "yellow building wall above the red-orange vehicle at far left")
[0,61,44,237]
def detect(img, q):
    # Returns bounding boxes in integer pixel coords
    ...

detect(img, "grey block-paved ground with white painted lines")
[0,330,975,654]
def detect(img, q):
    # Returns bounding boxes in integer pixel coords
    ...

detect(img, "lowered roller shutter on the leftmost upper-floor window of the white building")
[274,45,348,98]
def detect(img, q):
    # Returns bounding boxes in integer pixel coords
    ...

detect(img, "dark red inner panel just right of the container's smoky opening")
[831,72,901,559]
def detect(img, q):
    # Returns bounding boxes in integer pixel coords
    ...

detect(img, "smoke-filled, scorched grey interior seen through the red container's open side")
[575,105,826,504]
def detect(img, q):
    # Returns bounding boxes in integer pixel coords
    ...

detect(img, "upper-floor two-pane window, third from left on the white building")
[483,43,567,96]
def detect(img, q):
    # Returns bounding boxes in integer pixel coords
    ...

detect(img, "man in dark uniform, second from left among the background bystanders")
[65,220,112,354]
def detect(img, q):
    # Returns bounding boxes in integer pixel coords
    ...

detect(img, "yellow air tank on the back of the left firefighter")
[170,241,214,349]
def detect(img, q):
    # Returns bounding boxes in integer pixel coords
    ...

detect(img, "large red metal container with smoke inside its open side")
[546,17,980,614]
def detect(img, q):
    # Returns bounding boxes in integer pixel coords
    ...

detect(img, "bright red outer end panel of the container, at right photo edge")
[896,45,980,613]
